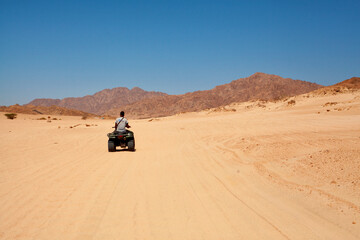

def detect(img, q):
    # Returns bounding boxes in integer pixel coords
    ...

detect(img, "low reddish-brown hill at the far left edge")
[0,104,95,117]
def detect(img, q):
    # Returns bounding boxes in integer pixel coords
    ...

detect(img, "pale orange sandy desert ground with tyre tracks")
[0,92,360,240]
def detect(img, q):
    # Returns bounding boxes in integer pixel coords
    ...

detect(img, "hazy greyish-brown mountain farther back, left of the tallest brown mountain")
[29,87,167,115]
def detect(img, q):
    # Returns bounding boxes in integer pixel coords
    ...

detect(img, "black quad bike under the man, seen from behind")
[107,131,135,152]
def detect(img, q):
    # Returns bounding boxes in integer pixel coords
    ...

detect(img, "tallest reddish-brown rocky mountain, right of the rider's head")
[107,73,322,118]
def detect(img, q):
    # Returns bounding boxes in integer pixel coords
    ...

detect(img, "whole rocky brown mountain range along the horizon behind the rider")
[23,73,323,118]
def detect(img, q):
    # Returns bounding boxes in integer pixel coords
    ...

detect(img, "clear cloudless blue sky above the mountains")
[0,0,360,105]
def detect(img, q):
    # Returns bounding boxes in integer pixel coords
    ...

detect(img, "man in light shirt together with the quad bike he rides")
[107,111,135,152]
